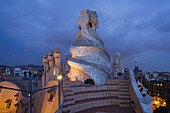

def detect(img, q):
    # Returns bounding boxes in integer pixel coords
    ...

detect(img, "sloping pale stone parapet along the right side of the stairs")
[127,71,152,113]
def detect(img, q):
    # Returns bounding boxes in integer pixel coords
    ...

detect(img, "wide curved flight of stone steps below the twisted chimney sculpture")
[62,80,131,113]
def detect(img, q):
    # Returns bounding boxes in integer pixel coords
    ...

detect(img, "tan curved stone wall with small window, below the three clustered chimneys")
[34,80,64,113]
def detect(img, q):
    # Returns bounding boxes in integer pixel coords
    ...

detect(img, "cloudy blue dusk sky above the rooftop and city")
[0,0,170,71]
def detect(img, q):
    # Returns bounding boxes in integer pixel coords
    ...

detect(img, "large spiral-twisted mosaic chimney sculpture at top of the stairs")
[67,10,110,85]
